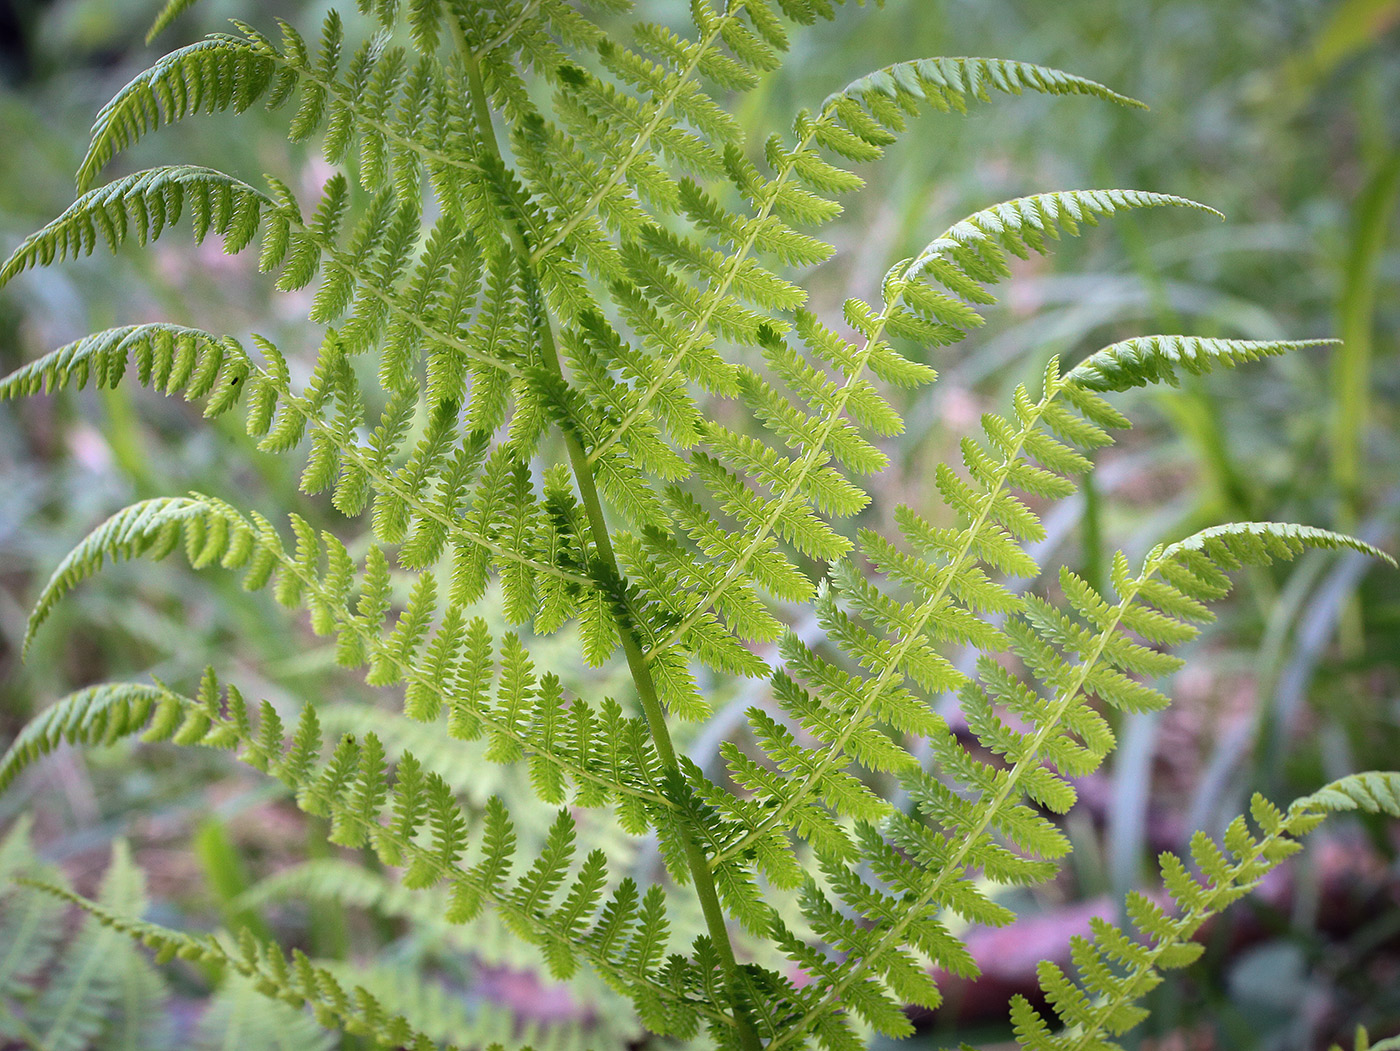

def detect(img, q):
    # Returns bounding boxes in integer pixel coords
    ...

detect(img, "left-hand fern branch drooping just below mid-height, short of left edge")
[15,494,666,824]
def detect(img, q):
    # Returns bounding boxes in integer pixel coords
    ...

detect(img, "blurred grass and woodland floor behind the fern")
[0,0,1400,1051]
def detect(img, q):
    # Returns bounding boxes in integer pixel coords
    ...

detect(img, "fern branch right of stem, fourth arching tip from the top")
[777,517,1385,1051]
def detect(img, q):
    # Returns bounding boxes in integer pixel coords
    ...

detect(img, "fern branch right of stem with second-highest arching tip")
[635,190,1208,722]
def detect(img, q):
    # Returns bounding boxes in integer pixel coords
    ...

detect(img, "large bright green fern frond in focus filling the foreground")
[0,0,1400,1051]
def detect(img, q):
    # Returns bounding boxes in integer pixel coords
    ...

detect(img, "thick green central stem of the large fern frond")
[448,15,762,1051]
